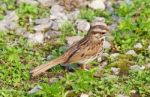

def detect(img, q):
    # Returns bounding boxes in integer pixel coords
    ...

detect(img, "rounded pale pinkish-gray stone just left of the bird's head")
[77,20,90,32]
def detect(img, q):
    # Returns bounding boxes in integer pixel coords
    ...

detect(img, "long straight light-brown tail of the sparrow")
[30,56,65,77]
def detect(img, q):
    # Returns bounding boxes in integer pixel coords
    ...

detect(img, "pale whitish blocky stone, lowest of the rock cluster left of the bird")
[28,32,44,43]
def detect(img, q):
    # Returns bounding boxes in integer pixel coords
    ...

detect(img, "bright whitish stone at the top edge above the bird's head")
[88,0,105,10]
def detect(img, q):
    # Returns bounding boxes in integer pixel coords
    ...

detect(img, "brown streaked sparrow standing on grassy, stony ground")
[30,21,109,77]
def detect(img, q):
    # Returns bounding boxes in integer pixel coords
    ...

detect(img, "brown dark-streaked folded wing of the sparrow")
[66,39,102,63]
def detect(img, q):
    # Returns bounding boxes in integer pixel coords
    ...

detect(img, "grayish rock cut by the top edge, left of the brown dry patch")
[38,0,56,7]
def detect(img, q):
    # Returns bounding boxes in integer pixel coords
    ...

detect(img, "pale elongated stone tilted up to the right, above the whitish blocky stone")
[33,22,52,32]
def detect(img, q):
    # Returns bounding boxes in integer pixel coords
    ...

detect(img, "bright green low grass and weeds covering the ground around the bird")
[0,0,150,97]
